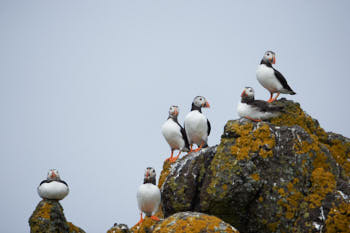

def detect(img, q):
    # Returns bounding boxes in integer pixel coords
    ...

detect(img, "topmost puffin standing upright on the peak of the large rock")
[256,51,296,103]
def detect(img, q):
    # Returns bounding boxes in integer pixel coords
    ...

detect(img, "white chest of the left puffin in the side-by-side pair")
[162,118,185,149]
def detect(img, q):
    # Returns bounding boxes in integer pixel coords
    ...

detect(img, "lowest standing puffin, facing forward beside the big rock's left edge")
[136,167,161,225]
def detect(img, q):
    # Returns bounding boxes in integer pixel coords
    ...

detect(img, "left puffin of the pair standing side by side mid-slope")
[162,105,189,162]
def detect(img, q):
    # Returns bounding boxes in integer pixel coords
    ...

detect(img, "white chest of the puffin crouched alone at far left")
[38,181,69,200]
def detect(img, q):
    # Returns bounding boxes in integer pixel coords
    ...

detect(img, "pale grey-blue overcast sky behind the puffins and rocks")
[0,0,350,233]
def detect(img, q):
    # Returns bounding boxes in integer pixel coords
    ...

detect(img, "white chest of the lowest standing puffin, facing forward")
[137,183,161,216]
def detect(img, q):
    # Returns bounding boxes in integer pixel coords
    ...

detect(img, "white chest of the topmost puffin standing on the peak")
[256,64,283,93]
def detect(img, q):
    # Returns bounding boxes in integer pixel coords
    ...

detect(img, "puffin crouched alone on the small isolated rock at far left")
[38,169,69,200]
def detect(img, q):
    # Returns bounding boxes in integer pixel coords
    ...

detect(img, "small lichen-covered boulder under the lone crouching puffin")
[29,200,85,233]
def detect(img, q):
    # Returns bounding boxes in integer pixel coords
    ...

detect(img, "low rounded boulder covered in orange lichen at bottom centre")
[153,212,238,233]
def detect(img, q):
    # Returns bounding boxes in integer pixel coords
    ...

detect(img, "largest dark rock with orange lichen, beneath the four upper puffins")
[161,99,350,232]
